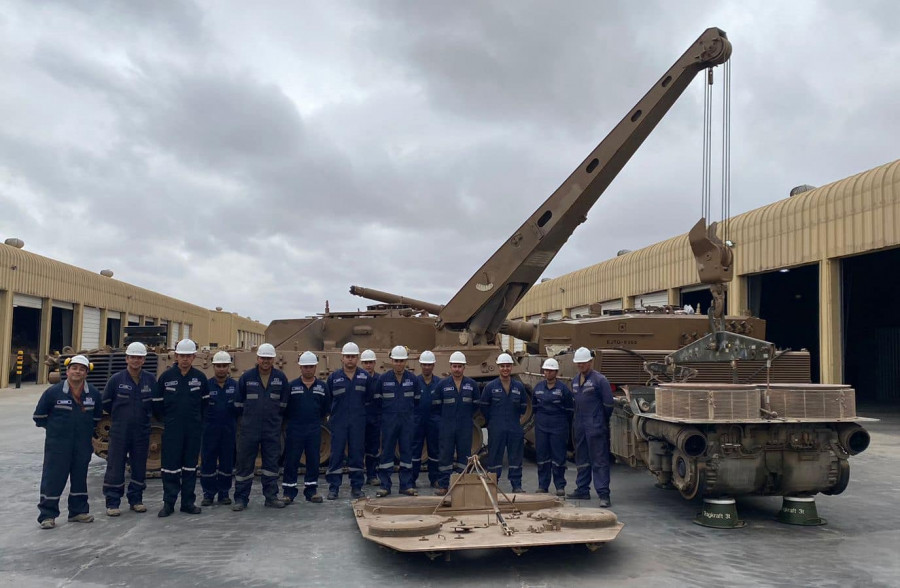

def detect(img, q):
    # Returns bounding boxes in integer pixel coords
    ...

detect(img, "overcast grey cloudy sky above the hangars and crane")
[0,0,900,322]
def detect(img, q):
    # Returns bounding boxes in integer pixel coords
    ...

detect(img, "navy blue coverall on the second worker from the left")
[103,369,156,508]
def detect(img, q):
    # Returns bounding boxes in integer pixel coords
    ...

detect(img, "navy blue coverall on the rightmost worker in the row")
[572,370,615,499]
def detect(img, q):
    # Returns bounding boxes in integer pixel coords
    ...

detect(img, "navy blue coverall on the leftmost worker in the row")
[32,380,103,522]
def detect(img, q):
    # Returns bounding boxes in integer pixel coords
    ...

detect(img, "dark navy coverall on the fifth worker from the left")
[234,367,291,506]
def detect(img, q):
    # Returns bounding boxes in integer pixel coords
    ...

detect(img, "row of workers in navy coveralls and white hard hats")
[33,339,613,529]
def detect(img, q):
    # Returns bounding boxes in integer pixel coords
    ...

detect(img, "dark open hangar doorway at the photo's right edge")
[841,249,900,404]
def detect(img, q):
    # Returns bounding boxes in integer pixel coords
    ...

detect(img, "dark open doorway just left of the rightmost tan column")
[747,264,819,382]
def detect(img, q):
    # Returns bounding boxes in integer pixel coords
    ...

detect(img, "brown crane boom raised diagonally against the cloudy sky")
[439,28,731,342]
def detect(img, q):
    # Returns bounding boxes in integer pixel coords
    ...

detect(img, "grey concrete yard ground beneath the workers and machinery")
[0,385,900,587]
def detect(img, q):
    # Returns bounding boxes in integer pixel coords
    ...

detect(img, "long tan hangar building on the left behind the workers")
[0,239,266,388]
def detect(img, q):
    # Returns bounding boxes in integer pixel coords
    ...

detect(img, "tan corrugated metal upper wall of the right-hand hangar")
[510,160,900,318]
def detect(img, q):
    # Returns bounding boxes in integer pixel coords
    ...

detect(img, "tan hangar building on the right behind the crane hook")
[510,160,900,402]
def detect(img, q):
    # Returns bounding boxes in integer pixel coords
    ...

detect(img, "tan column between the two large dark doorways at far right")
[819,259,844,384]
